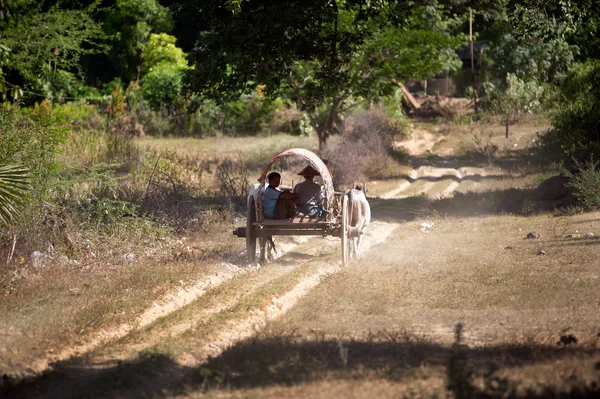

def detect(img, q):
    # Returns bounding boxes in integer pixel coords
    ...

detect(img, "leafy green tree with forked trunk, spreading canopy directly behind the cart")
[187,0,460,148]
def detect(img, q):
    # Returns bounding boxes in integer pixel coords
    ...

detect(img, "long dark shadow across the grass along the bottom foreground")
[5,331,600,398]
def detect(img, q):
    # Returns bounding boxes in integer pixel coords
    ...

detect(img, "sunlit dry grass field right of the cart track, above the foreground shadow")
[282,214,600,342]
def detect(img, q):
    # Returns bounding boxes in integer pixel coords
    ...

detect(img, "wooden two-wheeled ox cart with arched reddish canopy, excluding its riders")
[233,148,357,264]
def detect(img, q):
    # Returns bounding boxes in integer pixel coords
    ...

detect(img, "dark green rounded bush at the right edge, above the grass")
[552,60,600,159]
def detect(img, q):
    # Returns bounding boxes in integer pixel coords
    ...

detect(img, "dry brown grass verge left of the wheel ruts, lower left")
[0,226,243,375]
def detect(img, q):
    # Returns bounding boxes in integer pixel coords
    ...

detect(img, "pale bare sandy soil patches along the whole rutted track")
[18,122,536,373]
